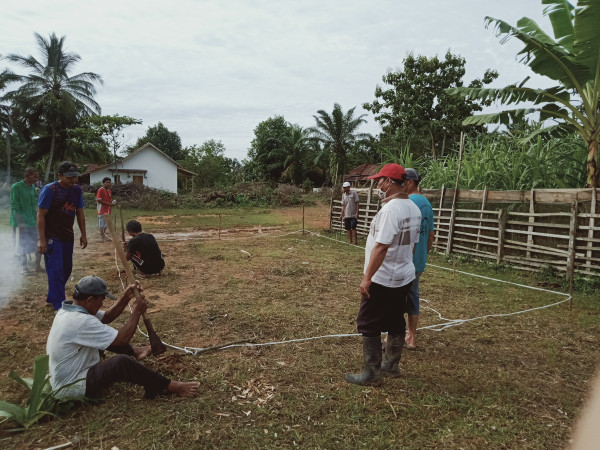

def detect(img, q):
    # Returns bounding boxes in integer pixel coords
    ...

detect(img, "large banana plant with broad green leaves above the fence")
[449,0,600,187]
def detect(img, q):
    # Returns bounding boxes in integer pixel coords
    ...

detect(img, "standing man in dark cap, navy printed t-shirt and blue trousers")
[37,161,87,310]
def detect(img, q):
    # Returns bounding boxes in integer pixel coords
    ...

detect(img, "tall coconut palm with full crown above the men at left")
[6,33,103,181]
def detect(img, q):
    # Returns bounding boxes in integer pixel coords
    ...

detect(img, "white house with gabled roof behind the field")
[81,142,197,194]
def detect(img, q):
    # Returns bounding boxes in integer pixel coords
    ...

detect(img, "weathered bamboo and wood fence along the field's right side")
[331,188,600,280]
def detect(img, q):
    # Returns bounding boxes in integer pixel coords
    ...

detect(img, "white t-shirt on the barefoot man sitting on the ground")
[46,302,118,397]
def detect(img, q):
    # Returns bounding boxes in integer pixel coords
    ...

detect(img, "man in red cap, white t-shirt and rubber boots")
[346,164,421,385]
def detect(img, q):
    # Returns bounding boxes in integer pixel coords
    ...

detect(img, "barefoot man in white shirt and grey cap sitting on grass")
[46,276,199,398]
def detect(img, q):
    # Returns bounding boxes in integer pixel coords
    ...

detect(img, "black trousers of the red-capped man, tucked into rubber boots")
[356,283,411,336]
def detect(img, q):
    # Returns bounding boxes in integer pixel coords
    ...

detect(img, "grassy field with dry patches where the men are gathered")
[0,206,600,449]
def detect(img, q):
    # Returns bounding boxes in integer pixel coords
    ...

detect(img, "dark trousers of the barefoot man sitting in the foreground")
[85,355,171,398]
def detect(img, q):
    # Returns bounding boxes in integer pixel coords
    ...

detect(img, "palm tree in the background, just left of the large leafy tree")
[309,103,371,180]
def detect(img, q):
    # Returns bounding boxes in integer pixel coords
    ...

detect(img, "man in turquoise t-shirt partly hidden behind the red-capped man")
[404,169,435,350]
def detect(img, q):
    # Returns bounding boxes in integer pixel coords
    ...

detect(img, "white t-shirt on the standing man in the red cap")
[364,198,421,287]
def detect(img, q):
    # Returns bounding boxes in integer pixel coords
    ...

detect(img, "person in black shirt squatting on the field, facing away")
[123,220,165,275]
